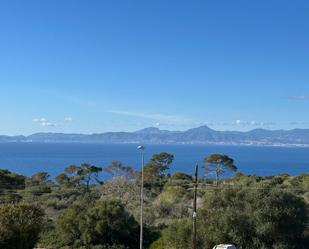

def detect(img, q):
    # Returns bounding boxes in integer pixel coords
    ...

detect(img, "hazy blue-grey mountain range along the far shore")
[0,126,309,147]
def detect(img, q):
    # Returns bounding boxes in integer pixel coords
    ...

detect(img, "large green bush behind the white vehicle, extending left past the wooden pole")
[155,189,308,249]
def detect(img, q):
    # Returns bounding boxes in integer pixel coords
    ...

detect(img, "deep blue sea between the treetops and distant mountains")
[0,143,309,178]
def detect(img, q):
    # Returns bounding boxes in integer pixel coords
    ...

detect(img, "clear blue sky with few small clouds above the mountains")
[0,0,309,135]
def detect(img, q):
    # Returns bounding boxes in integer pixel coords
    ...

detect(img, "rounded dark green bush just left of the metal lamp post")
[57,200,139,249]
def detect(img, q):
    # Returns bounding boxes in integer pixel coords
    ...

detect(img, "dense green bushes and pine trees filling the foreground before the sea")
[0,152,309,249]
